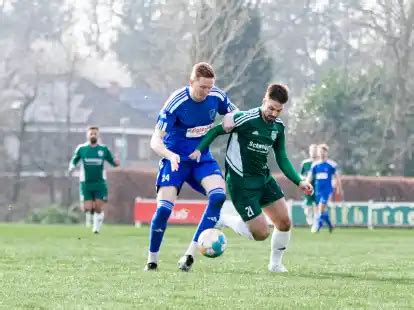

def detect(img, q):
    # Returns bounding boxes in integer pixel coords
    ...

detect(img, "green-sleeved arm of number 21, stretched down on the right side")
[273,130,313,193]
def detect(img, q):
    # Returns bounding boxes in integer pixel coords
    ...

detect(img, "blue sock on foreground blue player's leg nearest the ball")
[193,188,226,242]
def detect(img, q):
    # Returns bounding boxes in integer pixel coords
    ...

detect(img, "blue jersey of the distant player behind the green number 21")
[310,159,337,194]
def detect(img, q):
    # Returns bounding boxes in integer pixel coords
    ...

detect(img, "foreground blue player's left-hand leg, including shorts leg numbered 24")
[145,159,185,270]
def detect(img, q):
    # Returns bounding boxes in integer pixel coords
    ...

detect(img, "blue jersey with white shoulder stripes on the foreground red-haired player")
[156,86,236,161]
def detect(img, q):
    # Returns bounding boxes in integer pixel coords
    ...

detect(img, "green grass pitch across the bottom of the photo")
[0,225,414,310]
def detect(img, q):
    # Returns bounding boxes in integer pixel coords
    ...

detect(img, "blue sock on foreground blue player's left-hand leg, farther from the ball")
[149,200,174,253]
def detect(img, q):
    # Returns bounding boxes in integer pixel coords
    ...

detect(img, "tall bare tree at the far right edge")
[354,0,414,175]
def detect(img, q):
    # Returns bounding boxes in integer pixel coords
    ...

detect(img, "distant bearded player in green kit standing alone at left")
[69,126,119,233]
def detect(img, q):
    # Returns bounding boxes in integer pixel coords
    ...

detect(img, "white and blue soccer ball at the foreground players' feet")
[198,228,227,257]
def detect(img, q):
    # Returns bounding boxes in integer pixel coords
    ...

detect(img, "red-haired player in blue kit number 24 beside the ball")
[145,62,236,271]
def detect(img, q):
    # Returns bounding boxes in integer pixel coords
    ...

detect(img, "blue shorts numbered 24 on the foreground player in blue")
[156,158,223,195]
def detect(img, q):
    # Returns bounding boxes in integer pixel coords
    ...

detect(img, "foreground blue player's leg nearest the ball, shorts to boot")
[178,162,226,271]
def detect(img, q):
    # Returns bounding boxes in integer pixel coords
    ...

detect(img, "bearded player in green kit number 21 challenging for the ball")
[190,84,313,272]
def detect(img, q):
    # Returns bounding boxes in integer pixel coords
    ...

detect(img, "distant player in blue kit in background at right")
[308,144,342,232]
